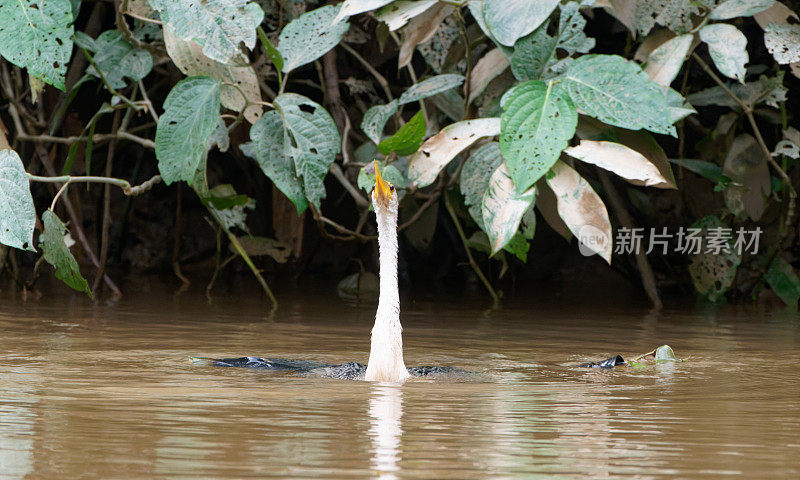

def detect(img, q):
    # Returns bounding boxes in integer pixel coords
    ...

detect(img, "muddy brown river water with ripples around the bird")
[0,291,800,479]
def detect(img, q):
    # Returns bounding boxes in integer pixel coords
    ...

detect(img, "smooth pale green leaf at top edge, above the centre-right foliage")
[483,0,559,47]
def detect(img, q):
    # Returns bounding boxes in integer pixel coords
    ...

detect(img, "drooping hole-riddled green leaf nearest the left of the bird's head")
[250,93,341,213]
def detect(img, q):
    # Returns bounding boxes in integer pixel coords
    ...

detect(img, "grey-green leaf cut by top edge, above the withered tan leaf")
[150,0,264,63]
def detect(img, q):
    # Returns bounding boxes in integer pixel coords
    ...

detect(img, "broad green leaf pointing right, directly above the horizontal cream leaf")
[562,55,676,136]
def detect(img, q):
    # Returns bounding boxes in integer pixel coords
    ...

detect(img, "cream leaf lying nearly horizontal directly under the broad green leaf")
[564,140,670,188]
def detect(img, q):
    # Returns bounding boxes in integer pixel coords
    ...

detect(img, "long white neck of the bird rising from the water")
[365,204,409,382]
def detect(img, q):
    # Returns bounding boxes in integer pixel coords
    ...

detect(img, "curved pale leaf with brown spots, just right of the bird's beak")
[408,118,500,188]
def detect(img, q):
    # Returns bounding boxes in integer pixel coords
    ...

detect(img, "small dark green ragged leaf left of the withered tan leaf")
[86,30,153,88]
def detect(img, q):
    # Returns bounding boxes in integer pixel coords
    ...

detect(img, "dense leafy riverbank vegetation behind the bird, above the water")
[0,0,800,307]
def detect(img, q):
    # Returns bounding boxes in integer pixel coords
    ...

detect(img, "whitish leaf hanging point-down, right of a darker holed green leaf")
[481,163,536,253]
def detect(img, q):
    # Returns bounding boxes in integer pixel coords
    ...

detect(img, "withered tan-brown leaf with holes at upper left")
[164,25,262,123]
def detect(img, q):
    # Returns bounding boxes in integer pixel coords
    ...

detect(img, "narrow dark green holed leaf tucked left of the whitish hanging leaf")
[458,142,503,230]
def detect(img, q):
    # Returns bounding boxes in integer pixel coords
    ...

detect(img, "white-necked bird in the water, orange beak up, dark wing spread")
[197,162,458,382]
